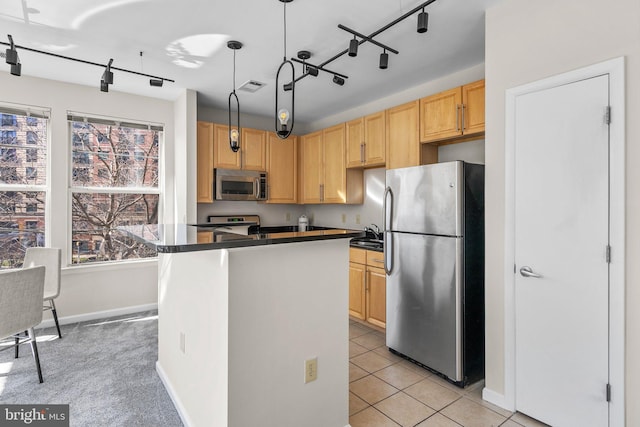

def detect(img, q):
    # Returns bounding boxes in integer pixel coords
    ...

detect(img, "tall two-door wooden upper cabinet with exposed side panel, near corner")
[300,123,363,204]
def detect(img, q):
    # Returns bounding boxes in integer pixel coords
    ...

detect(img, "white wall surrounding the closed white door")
[485,0,640,426]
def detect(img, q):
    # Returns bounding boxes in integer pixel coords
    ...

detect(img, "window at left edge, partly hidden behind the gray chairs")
[0,105,49,268]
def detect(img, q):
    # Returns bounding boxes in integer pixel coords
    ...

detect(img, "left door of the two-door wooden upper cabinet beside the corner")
[300,131,322,203]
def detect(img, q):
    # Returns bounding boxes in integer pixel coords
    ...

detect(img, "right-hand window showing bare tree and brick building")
[69,114,163,264]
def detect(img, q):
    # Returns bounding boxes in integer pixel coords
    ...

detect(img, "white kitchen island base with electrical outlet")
[156,239,349,427]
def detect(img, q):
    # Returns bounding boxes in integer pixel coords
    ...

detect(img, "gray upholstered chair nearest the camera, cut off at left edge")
[0,266,45,382]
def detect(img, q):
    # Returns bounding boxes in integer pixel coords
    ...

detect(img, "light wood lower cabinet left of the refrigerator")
[349,248,387,328]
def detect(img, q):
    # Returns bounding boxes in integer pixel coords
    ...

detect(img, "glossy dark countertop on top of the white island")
[118,224,364,253]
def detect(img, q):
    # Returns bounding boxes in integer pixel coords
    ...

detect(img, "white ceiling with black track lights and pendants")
[0,0,502,123]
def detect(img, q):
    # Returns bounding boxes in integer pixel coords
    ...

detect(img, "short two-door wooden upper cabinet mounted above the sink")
[346,111,386,168]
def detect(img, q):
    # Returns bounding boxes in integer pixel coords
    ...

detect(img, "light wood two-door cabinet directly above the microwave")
[213,124,267,171]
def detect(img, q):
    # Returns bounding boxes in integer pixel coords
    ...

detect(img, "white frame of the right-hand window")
[64,112,166,270]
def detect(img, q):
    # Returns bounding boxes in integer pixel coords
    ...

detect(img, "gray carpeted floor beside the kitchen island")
[0,312,182,427]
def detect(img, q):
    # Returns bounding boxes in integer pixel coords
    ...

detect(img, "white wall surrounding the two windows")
[0,72,185,322]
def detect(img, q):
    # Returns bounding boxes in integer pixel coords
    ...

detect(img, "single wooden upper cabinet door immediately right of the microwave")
[267,132,298,203]
